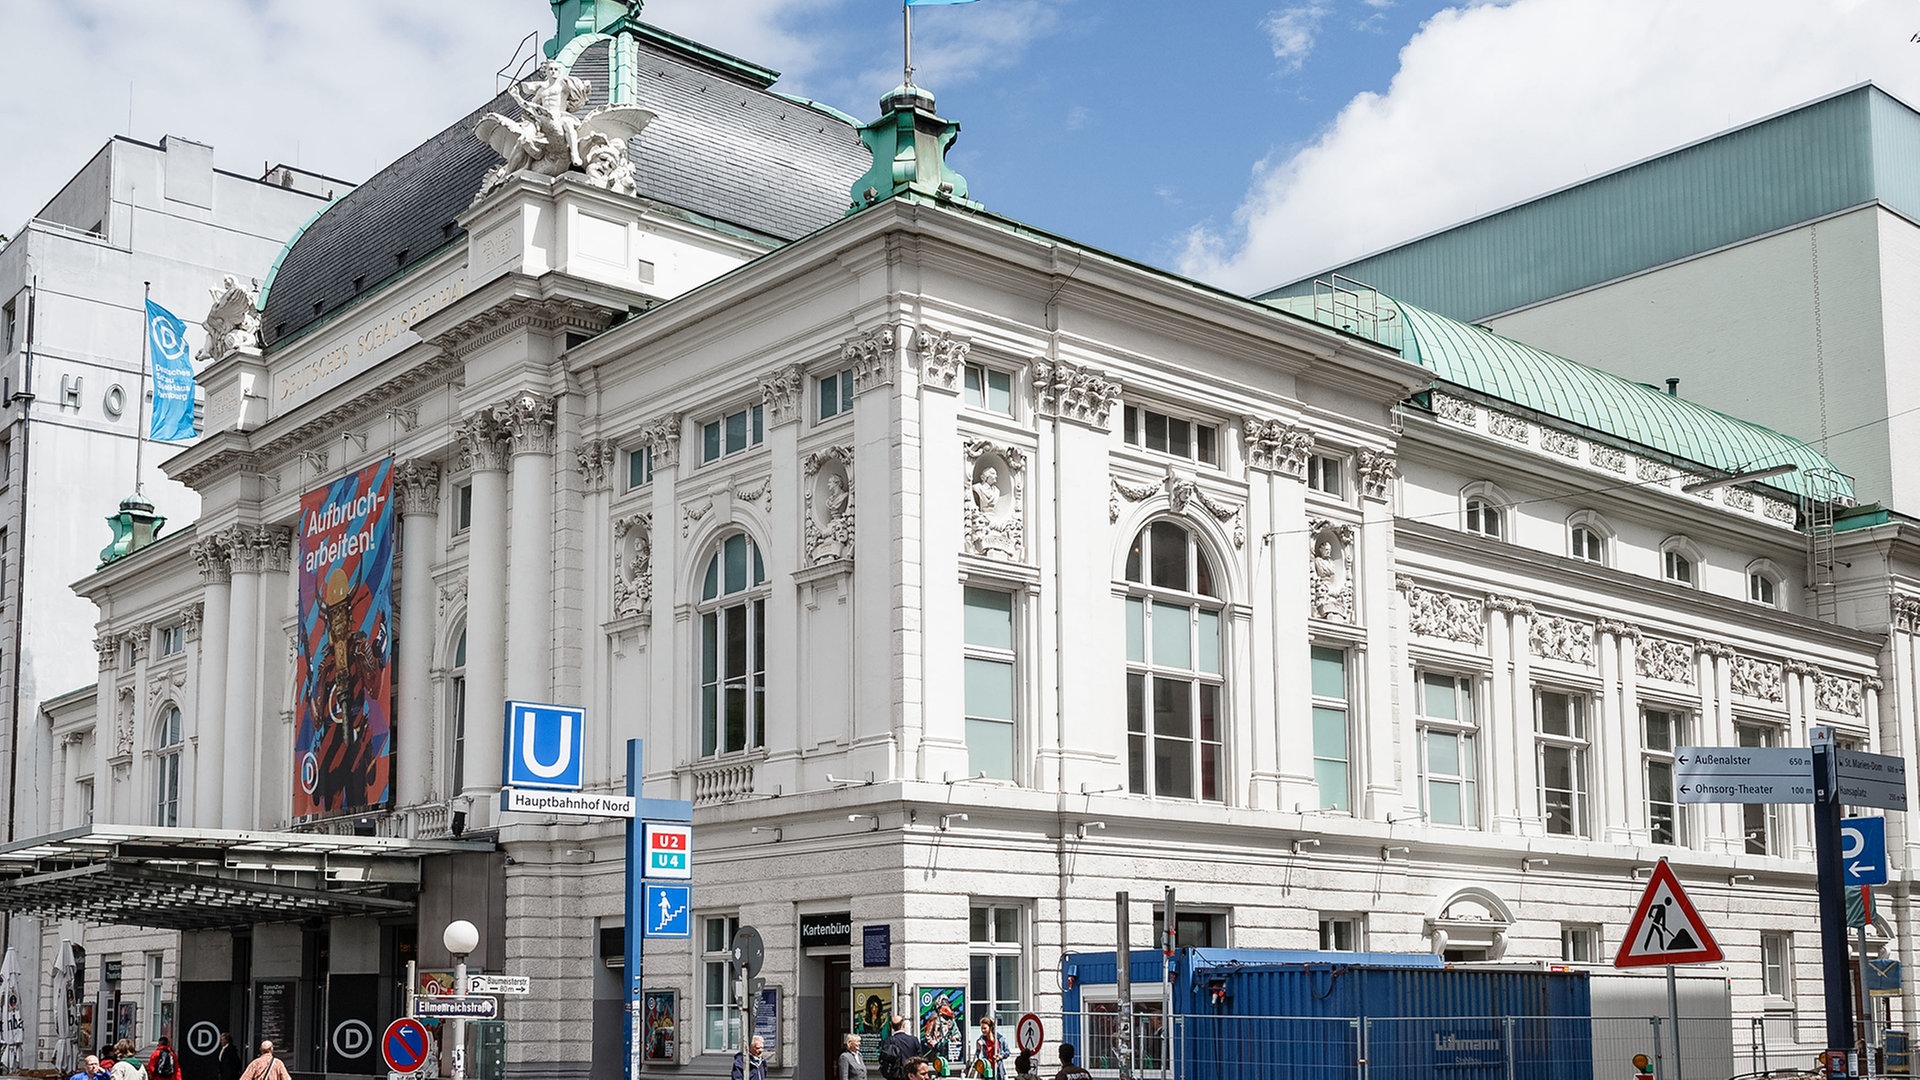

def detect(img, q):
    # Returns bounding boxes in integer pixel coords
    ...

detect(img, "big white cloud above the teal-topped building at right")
[1179,0,1920,290]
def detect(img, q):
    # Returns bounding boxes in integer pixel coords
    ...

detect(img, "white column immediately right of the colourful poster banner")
[392,461,440,807]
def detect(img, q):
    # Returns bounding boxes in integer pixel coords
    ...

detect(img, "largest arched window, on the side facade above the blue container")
[1127,521,1225,801]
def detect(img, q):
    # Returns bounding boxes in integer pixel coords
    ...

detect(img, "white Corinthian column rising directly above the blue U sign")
[499,390,553,701]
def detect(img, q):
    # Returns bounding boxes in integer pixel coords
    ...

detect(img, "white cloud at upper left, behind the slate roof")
[0,0,840,233]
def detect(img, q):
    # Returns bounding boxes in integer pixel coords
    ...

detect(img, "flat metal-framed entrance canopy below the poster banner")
[0,824,493,930]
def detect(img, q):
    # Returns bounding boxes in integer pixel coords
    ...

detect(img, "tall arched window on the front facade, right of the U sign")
[699,532,766,757]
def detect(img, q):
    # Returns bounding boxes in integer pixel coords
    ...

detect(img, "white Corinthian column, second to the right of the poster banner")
[459,409,507,807]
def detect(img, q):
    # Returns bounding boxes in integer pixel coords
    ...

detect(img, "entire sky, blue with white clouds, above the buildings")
[0,0,1920,290]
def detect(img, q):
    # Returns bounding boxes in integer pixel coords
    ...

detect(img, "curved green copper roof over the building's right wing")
[1394,295,1853,498]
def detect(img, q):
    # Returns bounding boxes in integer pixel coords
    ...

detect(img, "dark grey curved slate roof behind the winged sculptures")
[261,37,872,350]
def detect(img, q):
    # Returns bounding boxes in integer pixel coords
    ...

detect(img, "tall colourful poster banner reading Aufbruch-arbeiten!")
[294,457,394,819]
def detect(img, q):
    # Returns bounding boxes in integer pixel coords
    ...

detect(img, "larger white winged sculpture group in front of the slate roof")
[474,60,653,204]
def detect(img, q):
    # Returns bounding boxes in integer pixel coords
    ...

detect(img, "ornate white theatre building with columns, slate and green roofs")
[0,4,1920,1076]
